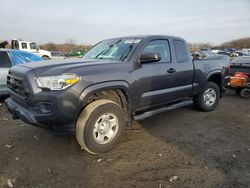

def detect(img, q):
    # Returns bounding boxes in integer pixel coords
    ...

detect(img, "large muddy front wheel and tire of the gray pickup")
[76,99,126,154]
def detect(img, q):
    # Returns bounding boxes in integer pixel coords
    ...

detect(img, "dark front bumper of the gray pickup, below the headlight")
[5,89,82,134]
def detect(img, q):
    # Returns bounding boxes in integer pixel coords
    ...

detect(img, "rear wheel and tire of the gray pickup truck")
[193,82,220,112]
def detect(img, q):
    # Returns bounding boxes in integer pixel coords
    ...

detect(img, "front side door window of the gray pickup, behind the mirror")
[142,40,171,63]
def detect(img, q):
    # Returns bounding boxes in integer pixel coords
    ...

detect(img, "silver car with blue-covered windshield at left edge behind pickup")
[0,49,43,96]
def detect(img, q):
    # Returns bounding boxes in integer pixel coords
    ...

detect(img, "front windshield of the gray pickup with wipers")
[83,39,141,61]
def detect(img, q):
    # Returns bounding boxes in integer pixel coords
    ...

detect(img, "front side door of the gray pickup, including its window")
[133,39,177,108]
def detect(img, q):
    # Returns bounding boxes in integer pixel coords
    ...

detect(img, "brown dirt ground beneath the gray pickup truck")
[0,92,250,188]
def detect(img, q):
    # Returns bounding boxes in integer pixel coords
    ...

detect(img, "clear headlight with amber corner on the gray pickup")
[36,74,80,90]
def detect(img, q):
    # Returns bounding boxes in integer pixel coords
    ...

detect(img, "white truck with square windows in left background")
[11,39,52,60]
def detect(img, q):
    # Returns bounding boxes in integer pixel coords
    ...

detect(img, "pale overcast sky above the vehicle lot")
[0,0,250,44]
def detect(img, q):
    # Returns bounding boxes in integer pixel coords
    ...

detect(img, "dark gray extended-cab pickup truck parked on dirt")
[6,36,229,153]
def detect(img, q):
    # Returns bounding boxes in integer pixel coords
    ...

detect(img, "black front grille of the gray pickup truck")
[7,74,29,98]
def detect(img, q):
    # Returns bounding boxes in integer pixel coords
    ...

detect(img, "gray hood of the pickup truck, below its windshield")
[18,58,121,76]
